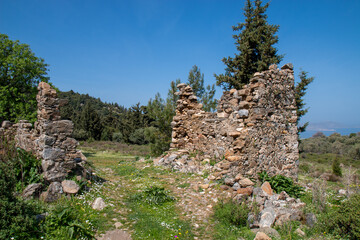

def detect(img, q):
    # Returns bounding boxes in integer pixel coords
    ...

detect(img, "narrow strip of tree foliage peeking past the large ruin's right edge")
[295,71,314,133]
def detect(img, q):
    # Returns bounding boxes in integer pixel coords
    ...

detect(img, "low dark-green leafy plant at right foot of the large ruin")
[258,171,304,198]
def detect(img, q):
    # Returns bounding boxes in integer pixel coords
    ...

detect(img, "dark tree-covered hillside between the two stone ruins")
[59,90,154,144]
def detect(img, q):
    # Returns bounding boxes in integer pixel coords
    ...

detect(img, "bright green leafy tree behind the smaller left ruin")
[0,33,49,122]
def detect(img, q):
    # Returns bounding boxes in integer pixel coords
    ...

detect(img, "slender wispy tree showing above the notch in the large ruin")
[187,65,217,112]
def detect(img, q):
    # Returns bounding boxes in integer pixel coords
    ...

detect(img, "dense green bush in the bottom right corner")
[328,194,360,240]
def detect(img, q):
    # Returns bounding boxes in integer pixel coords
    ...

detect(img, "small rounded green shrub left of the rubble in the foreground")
[214,200,250,227]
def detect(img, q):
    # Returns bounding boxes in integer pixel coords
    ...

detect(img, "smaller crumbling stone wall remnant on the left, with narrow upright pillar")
[0,82,86,183]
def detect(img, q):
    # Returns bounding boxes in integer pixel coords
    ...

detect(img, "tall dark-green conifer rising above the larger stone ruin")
[215,0,283,90]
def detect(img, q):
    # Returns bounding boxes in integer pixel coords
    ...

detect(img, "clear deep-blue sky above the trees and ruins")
[0,0,360,127]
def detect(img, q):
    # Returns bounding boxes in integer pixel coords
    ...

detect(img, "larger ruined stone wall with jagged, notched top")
[156,64,299,179]
